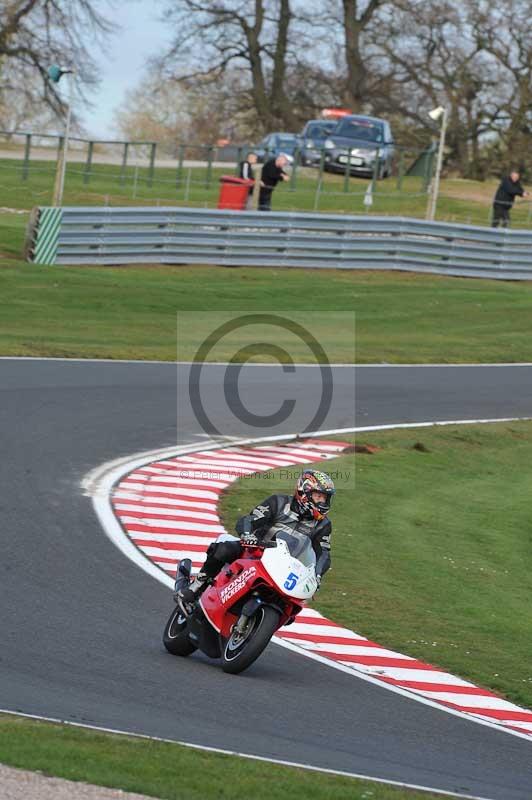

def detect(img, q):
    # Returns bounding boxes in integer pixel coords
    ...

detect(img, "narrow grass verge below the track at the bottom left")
[0,714,448,800]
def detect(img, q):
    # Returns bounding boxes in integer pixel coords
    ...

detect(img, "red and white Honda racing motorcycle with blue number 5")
[163,531,318,674]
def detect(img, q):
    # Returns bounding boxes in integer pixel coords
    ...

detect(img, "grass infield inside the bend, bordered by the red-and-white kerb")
[222,422,532,708]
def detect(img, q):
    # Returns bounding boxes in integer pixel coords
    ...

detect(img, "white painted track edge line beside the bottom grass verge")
[0,708,491,800]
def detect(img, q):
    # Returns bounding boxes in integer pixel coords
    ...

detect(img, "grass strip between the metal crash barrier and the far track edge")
[0,214,532,363]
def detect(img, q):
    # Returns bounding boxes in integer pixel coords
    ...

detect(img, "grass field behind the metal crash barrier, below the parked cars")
[0,159,532,228]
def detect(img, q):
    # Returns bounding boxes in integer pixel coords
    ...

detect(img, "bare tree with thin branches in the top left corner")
[0,0,113,124]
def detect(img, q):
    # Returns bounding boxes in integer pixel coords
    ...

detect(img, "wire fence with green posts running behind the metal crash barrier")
[0,131,532,228]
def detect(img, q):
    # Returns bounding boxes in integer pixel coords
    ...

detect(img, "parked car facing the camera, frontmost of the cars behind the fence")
[323,114,395,178]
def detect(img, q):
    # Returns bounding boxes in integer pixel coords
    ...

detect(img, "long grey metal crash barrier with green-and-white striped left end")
[30,207,532,280]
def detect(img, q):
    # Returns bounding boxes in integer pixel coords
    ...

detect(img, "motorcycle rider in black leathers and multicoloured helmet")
[175,469,336,613]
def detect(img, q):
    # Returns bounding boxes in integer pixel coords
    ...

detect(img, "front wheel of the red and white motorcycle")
[222,606,281,675]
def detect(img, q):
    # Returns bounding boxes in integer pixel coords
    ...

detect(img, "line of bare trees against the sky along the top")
[0,0,532,178]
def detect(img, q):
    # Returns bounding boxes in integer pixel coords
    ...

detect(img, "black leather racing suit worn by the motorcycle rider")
[201,494,332,578]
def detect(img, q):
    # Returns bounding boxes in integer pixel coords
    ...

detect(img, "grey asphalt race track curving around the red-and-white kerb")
[0,360,532,800]
